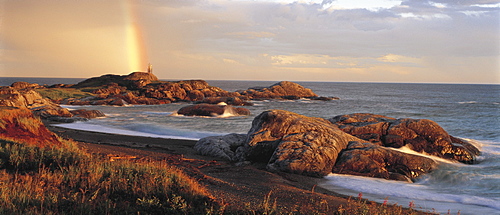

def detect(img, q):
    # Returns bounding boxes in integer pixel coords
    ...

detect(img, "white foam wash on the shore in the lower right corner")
[319,174,500,214]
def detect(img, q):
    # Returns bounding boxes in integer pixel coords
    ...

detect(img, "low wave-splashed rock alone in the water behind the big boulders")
[177,104,250,116]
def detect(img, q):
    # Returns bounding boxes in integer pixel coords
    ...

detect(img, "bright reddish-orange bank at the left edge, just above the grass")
[0,106,62,147]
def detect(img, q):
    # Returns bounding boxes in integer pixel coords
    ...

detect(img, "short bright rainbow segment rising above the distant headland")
[125,0,148,71]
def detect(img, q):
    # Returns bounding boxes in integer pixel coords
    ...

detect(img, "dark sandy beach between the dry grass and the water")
[47,125,347,213]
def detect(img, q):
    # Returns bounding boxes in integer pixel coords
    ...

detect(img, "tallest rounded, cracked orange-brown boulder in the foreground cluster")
[240,110,362,176]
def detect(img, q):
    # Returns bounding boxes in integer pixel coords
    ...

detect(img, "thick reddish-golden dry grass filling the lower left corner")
[0,141,219,214]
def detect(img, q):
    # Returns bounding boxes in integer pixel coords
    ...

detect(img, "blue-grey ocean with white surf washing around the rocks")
[0,78,500,214]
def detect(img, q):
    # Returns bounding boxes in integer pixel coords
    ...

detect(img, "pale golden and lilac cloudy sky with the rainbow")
[0,0,500,84]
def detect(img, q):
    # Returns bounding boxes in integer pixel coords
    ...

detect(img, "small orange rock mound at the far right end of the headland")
[239,81,318,99]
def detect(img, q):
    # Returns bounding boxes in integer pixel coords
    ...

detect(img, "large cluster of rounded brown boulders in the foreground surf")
[195,110,479,181]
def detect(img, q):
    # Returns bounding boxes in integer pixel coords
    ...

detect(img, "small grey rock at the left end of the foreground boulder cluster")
[194,133,247,161]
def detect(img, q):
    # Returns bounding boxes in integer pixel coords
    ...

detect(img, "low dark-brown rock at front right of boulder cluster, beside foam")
[333,141,438,182]
